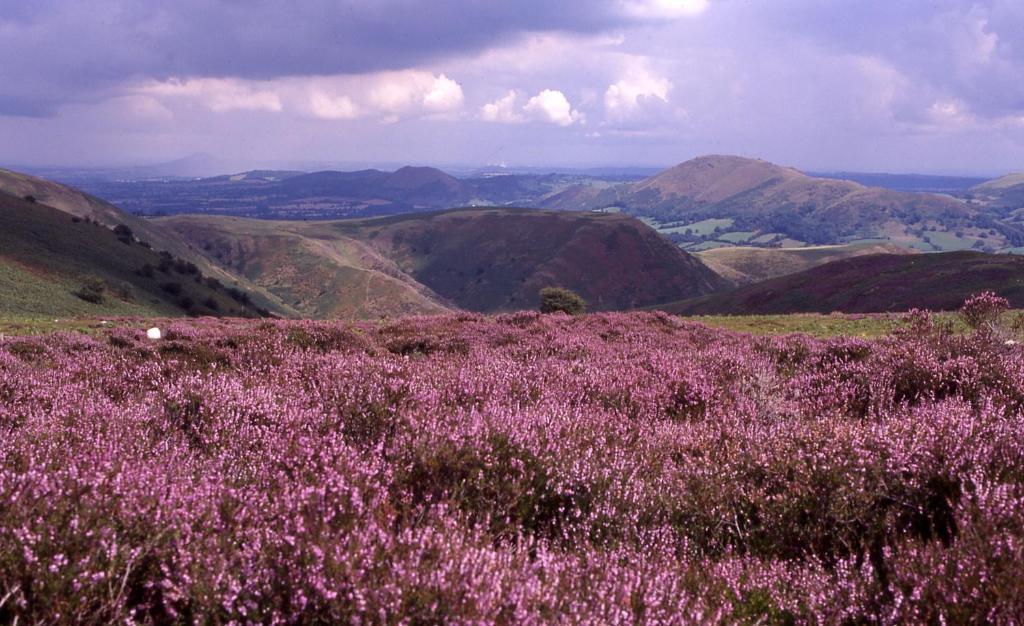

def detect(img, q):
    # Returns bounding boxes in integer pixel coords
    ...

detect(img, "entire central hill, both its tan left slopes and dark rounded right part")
[158,208,726,317]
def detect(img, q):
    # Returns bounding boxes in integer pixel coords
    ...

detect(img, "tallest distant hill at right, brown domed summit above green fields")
[592,156,1024,250]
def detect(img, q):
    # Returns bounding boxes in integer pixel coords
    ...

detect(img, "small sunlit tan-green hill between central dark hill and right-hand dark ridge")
[696,244,916,285]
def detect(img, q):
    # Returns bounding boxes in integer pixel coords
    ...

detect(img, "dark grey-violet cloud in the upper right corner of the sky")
[742,0,1024,117]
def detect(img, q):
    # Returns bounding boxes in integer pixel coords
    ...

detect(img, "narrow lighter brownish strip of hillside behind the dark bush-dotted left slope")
[0,169,296,316]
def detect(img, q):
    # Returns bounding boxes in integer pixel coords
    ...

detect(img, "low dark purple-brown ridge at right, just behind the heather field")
[662,251,1024,315]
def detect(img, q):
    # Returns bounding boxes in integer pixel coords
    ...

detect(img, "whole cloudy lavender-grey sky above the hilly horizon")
[0,0,1024,175]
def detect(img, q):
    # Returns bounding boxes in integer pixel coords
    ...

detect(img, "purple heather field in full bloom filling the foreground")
[0,296,1024,624]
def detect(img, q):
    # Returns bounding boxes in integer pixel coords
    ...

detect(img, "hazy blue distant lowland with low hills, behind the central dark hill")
[64,166,635,220]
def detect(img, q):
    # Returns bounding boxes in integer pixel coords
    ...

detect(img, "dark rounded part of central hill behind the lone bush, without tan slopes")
[334,208,724,311]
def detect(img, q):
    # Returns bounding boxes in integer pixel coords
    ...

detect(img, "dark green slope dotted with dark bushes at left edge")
[0,193,268,317]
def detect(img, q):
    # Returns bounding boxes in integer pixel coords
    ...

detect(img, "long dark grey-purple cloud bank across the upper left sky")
[0,0,629,116]
